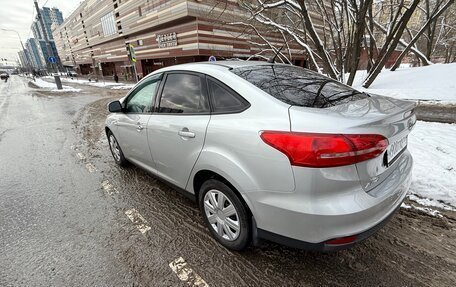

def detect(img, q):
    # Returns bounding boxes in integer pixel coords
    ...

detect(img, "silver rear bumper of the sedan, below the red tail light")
[246,151,413,250]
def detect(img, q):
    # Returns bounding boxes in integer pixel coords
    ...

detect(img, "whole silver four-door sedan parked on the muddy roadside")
[106,61,416,251]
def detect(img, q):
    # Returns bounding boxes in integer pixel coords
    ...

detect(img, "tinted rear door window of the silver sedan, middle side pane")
[158,74,210,114]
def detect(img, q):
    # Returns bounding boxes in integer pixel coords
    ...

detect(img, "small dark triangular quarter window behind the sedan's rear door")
[208,78,249,113]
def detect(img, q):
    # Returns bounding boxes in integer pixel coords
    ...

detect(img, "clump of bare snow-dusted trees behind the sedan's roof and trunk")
[208,0,456,88]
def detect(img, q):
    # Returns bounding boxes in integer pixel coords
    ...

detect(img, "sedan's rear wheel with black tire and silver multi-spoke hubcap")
[198,179,252,251]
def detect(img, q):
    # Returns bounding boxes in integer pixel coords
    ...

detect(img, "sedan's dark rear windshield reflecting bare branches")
[231,65,369,108]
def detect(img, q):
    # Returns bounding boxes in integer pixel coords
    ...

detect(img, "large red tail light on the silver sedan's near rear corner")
[261,131,388,167]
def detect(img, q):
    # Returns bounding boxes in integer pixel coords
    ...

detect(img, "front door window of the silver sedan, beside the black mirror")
[125,76,160,114]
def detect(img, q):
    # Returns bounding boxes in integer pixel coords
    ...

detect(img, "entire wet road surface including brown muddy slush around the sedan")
[0,76,456,286]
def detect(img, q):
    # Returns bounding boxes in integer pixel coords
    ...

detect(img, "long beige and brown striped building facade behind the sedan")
[53,0,305,78]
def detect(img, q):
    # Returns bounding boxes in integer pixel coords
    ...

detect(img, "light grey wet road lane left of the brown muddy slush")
[0,76,132,286]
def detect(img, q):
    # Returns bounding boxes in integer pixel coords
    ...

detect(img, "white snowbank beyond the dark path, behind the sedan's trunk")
[353,63,456,102]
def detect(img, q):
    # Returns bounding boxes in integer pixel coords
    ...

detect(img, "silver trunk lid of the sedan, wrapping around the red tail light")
[289,95,416,192]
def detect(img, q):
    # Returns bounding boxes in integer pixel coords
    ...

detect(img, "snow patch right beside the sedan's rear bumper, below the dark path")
[408,121,456,210]
